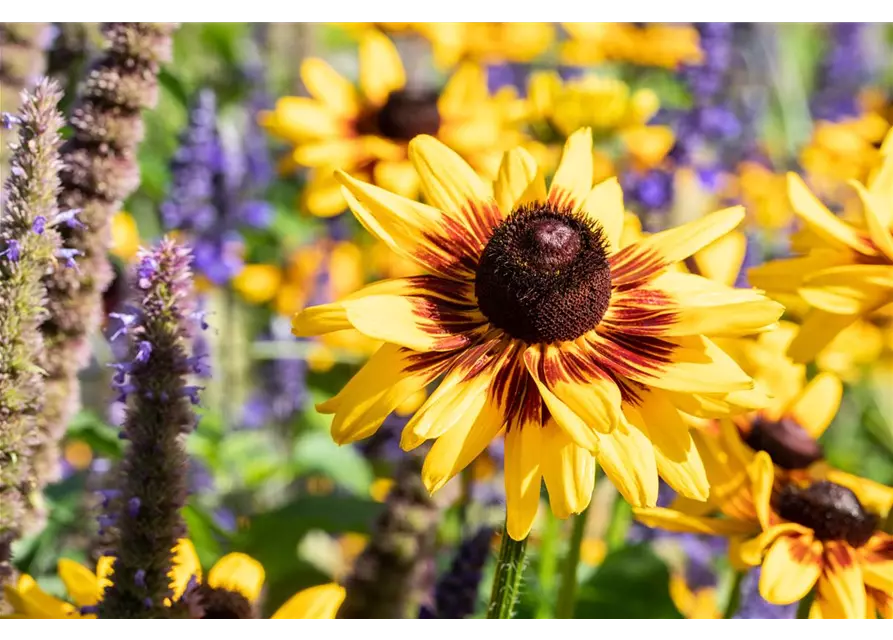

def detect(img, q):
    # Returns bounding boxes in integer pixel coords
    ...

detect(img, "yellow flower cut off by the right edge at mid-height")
[749,130,893,362]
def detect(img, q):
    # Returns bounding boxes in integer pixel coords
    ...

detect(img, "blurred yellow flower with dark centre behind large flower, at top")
[261,30,521,216]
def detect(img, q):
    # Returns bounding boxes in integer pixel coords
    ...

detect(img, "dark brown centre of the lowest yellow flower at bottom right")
[778,480,880,547]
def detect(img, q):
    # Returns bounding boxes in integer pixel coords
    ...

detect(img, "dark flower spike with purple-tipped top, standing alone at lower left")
[100,239,198,621]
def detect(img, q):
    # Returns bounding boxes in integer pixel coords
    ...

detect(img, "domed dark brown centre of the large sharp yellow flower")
[474,204,611,343]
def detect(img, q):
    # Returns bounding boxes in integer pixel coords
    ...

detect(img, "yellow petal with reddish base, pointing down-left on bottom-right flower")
[760,536,824,610]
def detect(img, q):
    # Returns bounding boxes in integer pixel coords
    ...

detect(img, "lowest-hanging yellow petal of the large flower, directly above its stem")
[505,420,543,540]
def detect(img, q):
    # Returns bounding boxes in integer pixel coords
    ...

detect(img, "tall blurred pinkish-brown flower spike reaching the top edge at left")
[36,22,177,496]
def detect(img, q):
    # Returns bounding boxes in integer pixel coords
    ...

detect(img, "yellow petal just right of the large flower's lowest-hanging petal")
[542,420,595,519]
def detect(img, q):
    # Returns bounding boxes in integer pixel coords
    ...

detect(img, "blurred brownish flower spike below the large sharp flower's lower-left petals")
[337,450,439,622]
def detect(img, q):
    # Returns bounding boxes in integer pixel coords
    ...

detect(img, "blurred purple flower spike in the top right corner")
[810,22,869,122]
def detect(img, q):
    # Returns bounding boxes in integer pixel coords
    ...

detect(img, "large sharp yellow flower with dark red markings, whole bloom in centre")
[292,129,782,540]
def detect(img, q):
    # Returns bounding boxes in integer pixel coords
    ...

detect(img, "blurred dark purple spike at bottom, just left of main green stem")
[420,527,495,622]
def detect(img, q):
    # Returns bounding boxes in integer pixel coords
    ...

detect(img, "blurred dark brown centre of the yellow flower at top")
[358,91,440,140]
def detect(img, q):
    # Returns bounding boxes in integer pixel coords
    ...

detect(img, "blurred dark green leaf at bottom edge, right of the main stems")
[574,544,682,620]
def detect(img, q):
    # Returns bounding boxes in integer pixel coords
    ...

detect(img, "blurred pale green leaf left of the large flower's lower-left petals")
[293,431,373,495]
